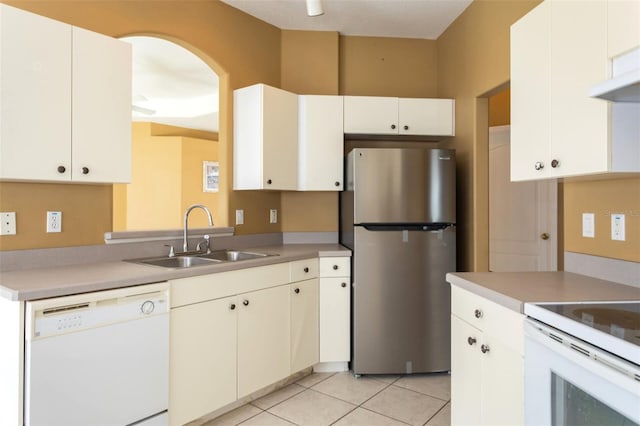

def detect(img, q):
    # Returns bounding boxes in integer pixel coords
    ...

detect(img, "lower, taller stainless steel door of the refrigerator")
[352,226,456,374]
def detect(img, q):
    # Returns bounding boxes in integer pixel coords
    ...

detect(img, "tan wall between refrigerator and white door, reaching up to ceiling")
[437,0,539,271]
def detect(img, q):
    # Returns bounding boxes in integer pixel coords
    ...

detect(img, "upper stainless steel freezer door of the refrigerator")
[343,148,456,224]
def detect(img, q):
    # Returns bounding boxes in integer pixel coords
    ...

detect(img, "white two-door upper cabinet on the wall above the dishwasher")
[0,4,131,183]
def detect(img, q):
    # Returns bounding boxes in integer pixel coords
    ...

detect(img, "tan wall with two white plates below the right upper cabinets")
[564,178,640,262]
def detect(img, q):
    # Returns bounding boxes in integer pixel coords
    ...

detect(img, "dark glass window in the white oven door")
[551,373,639,426]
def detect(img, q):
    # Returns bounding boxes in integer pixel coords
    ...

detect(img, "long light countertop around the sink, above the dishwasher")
[0,244,351,300]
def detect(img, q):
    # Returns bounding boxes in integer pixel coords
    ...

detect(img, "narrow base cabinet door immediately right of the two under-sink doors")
[290,278,319,373]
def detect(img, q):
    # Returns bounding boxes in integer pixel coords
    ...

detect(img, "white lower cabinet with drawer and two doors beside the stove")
[451,286,524,425]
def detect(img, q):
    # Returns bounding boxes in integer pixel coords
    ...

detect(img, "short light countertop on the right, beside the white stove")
[447,272,640,313]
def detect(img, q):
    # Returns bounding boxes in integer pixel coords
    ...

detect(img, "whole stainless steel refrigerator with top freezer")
[340,148,456,374]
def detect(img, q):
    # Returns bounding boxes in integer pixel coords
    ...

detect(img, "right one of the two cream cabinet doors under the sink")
[238,285,291,398]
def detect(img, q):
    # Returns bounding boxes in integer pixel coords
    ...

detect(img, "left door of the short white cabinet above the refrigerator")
[344,96,398,135]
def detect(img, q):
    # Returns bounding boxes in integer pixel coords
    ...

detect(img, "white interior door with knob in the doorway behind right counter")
[489,126,558,272]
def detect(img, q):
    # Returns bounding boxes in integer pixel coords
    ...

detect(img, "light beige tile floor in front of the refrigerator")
[206,372,451,426]
